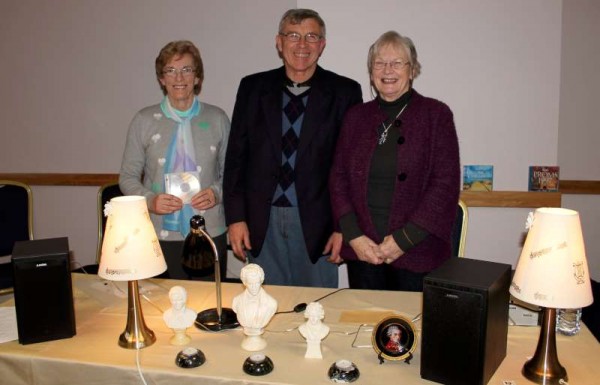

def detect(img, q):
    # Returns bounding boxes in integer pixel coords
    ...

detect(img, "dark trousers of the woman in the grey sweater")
[159,233,227,282]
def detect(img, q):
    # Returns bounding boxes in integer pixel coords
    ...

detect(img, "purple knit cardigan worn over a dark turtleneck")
[329,91,460,272]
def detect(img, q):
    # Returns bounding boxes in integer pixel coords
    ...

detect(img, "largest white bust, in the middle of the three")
[232,263,277,352]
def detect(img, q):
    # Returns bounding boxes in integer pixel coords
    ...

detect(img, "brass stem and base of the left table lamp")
[119,281,156,349]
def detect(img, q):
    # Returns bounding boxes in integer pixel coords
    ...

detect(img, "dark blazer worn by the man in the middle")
[223,67,362,262]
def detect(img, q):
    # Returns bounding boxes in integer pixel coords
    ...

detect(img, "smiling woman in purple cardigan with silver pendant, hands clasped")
[330,31,460,291]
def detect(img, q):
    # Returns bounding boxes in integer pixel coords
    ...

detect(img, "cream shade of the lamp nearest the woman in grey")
[98,196,167,281]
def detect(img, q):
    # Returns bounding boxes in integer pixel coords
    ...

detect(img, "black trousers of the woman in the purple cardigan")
[346,261,427,291]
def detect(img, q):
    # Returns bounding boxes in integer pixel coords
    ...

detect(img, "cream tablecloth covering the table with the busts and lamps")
[0,274,600,385]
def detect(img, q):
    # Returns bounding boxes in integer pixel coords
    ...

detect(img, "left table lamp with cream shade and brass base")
[98,196,167,349]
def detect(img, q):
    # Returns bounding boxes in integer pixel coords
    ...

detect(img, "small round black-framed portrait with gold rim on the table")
[371,316,417,361]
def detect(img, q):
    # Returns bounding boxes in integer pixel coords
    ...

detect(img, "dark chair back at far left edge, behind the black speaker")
[0,180,33,293]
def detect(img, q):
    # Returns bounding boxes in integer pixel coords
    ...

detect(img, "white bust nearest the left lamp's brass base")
[163,286,196,345]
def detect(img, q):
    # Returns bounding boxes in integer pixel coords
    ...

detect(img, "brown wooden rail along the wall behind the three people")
[0,173,600,208]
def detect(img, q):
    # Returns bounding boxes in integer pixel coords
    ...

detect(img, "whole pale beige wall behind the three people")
[0,0,600,279]
